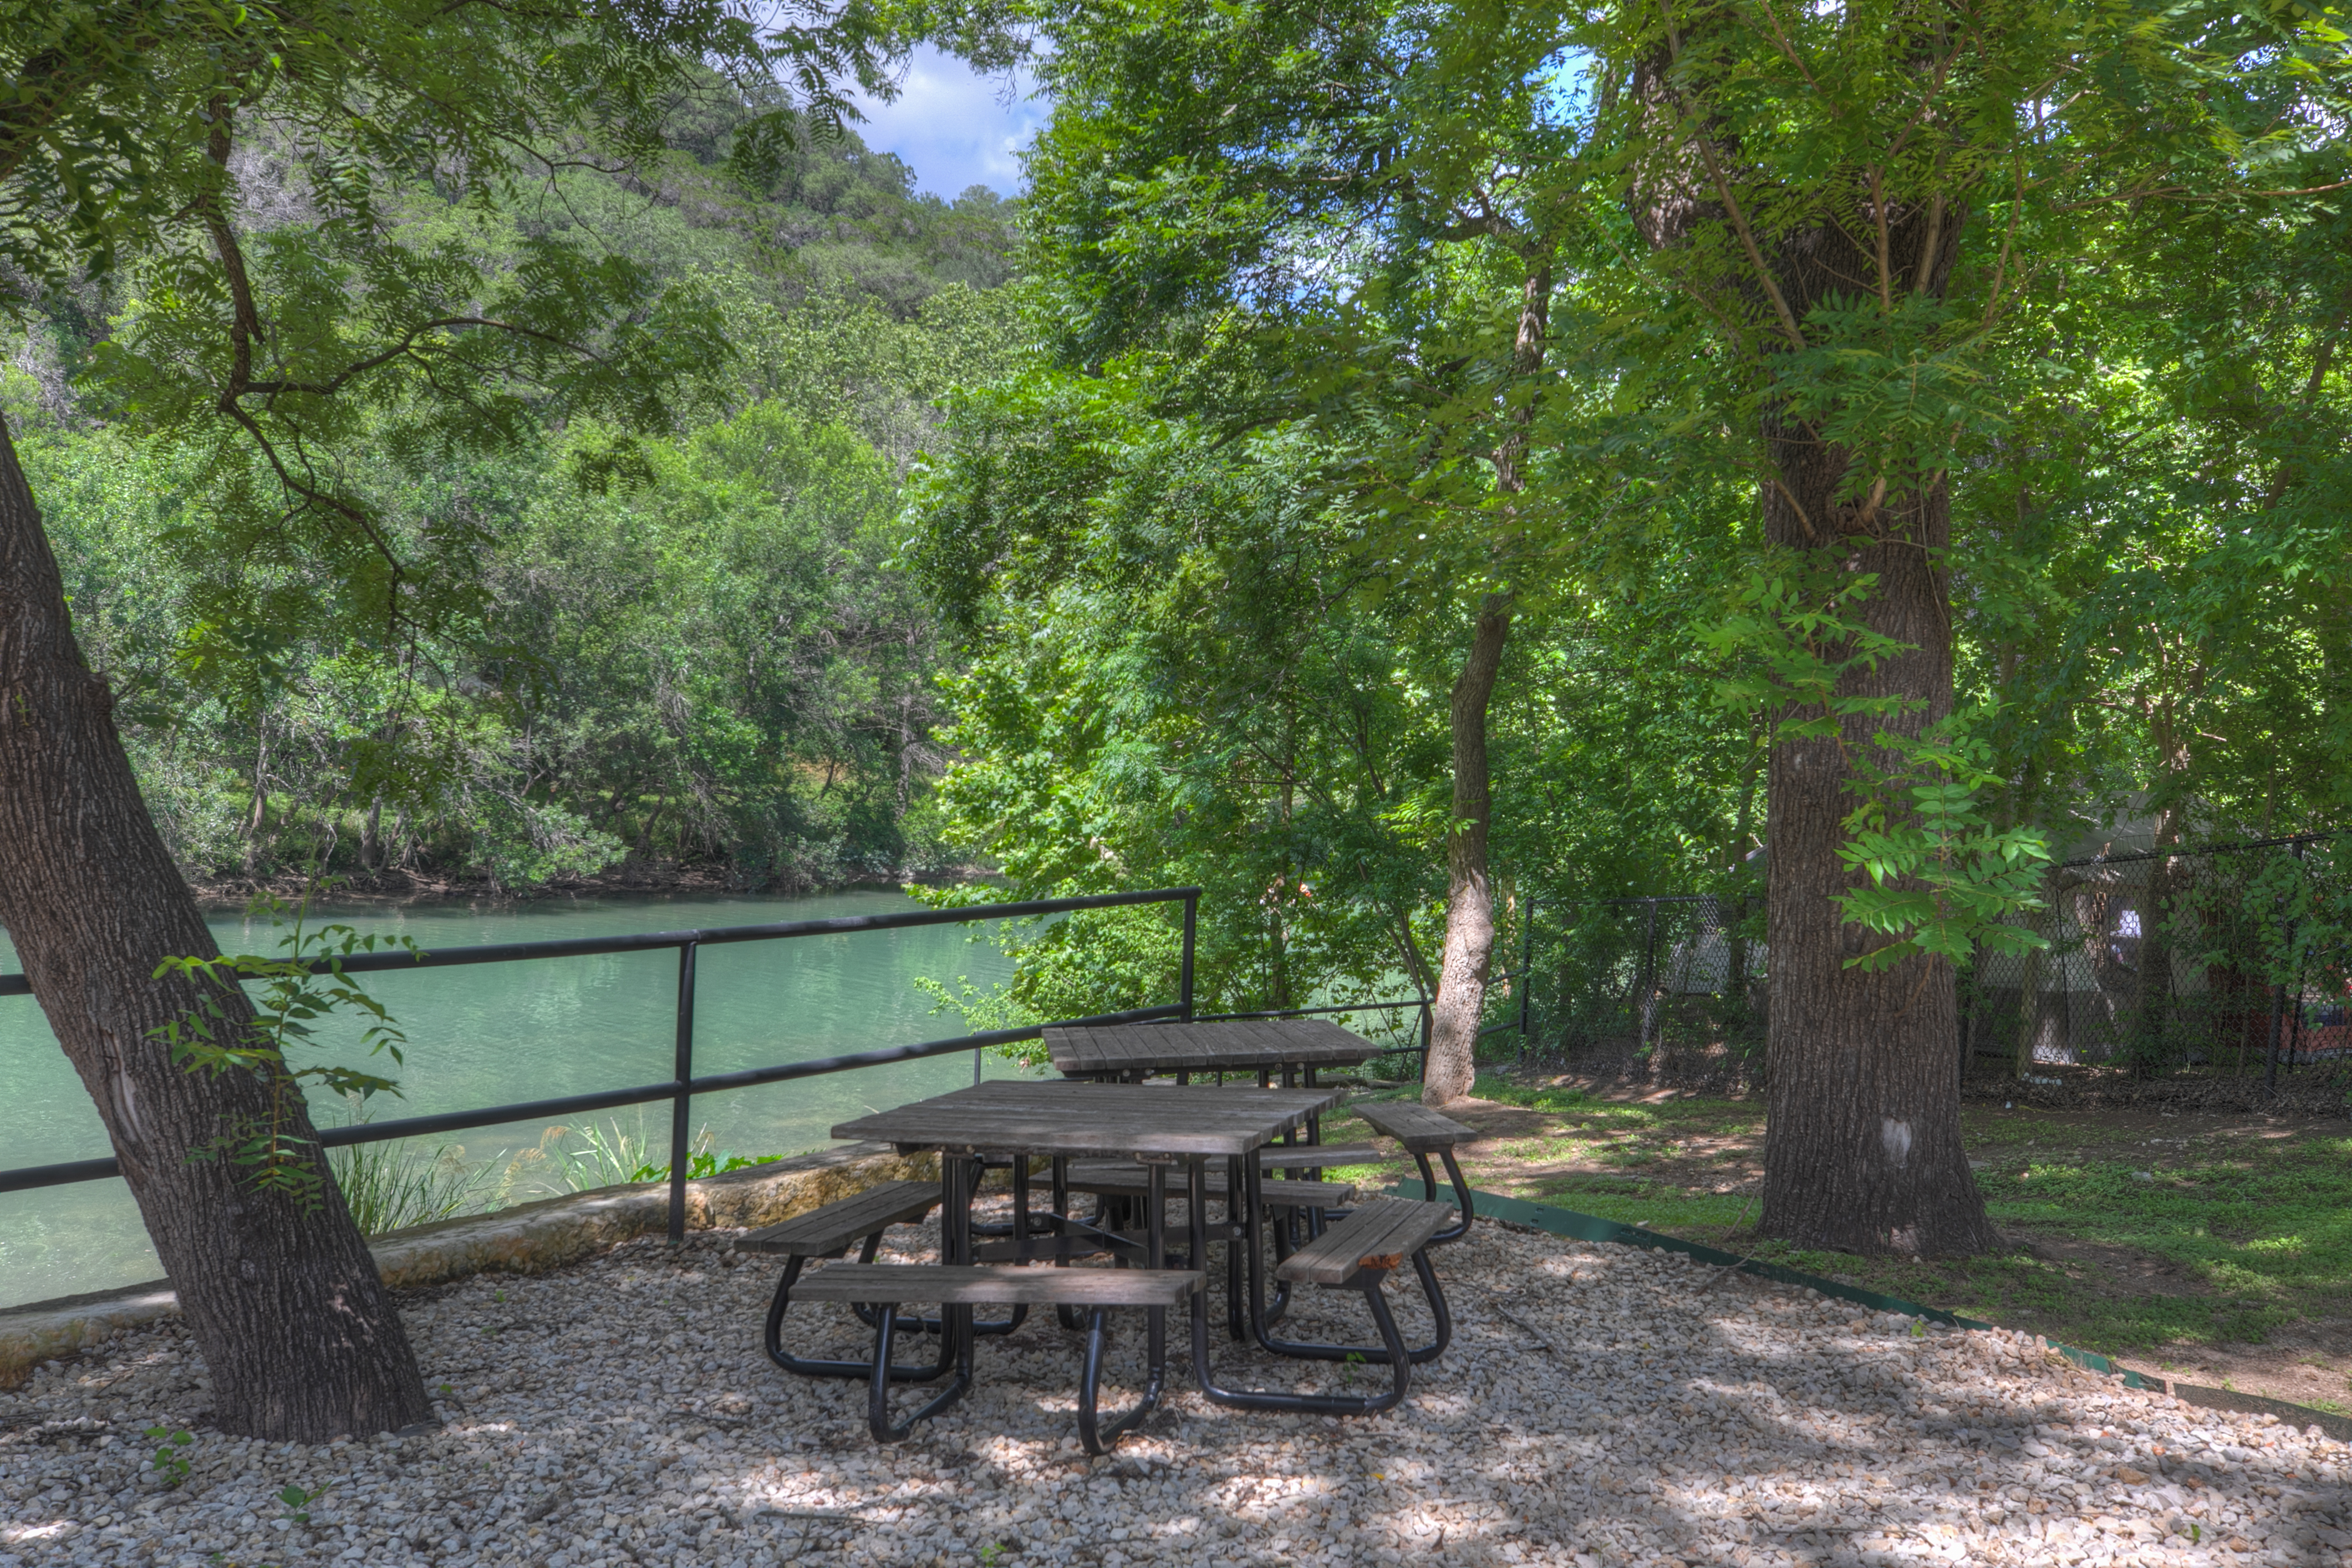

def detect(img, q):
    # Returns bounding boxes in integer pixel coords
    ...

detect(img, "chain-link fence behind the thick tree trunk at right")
[1494,834,2352,1084]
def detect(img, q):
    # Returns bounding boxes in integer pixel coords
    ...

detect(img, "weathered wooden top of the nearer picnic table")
[833,1079,1343,1159]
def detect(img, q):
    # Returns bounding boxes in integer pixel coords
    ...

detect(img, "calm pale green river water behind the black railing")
[0,891,1014,1307]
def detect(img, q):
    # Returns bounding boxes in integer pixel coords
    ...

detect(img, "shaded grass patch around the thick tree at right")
[1364,1079,2352,1352]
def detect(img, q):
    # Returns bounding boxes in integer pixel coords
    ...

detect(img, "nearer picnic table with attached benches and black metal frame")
[769,1081,1451,1453]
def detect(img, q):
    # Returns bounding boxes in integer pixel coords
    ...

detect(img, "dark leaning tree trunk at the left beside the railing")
[0,411,433,1443]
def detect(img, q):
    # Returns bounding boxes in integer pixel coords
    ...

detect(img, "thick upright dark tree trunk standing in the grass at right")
[1757,202,1999,1258]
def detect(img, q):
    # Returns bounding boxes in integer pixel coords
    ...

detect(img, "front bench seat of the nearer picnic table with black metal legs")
[800,1262,1204,1453]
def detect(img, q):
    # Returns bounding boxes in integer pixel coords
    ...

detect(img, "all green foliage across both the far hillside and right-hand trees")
[7,0,2352,1053]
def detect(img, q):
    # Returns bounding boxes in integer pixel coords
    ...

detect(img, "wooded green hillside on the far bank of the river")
[7,106,1019,889]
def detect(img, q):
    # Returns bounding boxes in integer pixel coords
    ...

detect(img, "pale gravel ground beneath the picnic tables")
[0,1223,2352,1568]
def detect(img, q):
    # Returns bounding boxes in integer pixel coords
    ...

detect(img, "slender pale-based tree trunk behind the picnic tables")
[1421,595,1510,1105]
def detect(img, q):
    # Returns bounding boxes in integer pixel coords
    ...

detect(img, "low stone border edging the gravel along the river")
[0,1143,939,1389]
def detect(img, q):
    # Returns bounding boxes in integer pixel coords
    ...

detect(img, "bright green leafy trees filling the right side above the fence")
[889,0,2352,1053]
